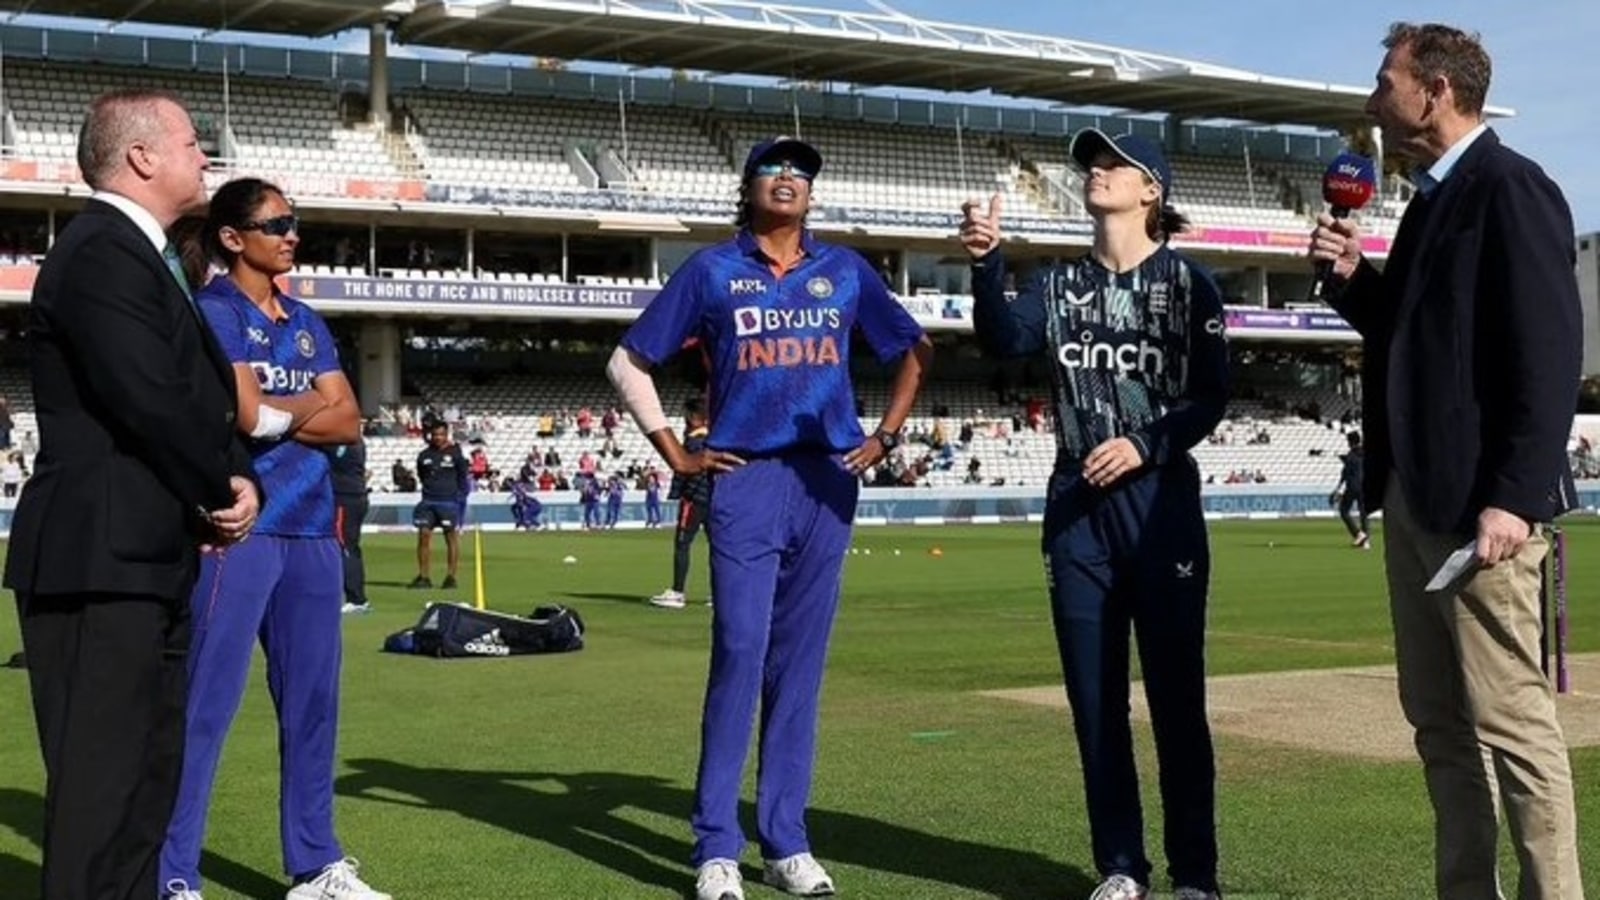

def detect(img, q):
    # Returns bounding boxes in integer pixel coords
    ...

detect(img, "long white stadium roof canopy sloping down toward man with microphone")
[397,0,1510,130]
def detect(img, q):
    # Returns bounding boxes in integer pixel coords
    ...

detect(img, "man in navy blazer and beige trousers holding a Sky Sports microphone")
[1310,24,1582,900]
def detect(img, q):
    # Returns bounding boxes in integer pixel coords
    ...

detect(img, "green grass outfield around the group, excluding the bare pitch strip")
[0,520,1600,900]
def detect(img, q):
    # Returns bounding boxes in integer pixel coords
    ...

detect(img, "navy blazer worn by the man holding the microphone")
[1331,131,1582,535]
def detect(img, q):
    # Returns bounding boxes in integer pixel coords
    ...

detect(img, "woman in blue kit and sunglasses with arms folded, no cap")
[162,178,389,900]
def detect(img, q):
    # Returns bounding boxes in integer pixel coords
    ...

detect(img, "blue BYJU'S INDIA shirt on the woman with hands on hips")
[622,231,922,455]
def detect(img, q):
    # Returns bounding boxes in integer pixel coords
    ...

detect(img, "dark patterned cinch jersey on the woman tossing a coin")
[973,245,1227,466]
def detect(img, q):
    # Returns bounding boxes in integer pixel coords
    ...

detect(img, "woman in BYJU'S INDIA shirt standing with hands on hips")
[608,138,933,900]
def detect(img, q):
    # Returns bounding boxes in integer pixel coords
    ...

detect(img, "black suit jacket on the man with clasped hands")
[5,200,266,599]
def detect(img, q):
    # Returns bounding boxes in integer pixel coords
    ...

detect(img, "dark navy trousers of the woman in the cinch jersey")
[1043,460,1218,890]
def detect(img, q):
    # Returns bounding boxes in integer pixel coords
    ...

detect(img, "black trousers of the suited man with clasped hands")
[18,594,189,900]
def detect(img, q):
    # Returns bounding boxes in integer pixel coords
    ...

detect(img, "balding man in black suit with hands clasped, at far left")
[5,90,259,900]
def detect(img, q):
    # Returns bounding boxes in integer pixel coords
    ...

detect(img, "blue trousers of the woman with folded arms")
[162,535,344,890]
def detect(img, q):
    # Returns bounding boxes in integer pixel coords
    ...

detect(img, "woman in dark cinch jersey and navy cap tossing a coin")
[962,128,1227,900]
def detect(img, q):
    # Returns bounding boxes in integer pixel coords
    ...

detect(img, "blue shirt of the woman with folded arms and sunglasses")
[195,275,339,538]
